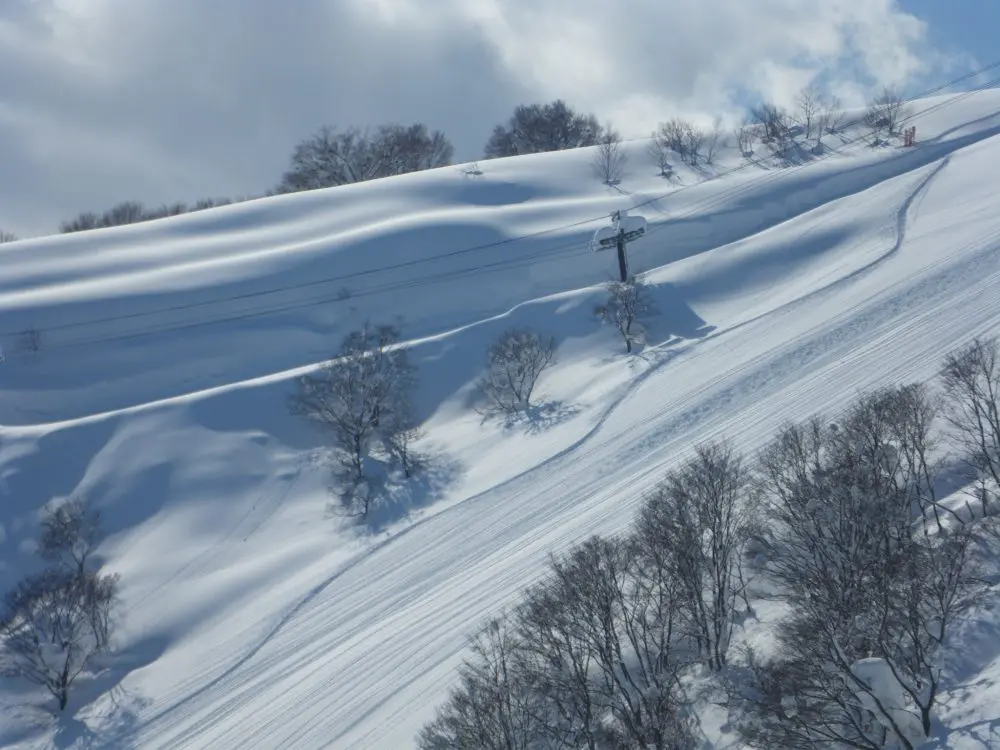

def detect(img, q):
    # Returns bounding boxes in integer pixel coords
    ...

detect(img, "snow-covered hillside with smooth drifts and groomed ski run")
[0,91,1000,750]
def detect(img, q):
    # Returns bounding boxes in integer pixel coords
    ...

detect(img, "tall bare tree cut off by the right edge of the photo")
[942,337,1000,511]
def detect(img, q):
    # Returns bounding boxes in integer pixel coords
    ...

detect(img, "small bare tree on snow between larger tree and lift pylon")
[479,328,556,414]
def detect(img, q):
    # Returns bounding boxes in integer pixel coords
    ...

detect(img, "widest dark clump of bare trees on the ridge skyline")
[277,124,453,193]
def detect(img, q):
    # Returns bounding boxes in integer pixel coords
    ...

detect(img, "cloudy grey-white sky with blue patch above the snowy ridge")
[0,0,1000,236]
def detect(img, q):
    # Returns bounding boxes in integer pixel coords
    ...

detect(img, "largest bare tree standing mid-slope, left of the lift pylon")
[290,323,416,517]
